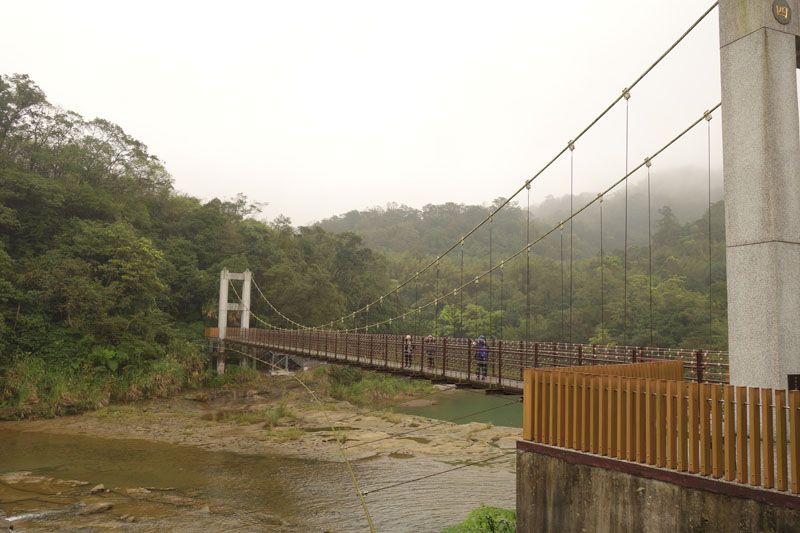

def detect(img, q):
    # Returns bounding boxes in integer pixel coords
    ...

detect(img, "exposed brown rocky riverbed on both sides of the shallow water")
[0,377,521,531]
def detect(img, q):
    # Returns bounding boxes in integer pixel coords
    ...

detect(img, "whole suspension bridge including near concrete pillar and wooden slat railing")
[206,0,800,523]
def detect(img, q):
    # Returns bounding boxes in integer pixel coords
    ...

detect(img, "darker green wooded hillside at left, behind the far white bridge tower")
[0,75,389,406]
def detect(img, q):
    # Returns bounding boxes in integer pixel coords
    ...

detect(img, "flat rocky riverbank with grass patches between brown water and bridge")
[0,373,521,461]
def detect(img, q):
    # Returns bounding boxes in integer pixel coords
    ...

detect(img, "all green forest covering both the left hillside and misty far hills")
[0,71,727,412]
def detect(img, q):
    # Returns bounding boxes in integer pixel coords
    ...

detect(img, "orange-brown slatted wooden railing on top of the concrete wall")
[523,363,800,494]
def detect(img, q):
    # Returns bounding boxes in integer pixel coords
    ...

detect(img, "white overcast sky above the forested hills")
[0,0,744,225]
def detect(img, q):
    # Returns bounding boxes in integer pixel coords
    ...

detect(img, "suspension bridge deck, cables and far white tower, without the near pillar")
[207,3,730,390]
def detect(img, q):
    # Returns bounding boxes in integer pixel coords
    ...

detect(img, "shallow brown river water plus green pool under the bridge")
[0,391,515,532]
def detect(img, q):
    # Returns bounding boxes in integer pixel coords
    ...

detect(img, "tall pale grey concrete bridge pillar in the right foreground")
[719,0,800,389]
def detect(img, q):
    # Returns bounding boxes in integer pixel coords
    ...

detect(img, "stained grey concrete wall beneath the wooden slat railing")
[517,443,800,533]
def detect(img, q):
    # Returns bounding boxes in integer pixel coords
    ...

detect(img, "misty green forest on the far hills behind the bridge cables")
[320,179,727,349]
